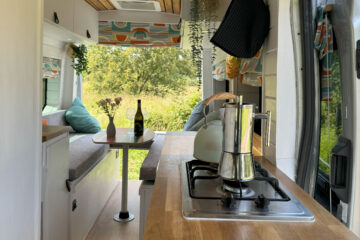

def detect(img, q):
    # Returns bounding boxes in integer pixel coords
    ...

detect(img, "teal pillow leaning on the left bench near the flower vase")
[65,97,101,133]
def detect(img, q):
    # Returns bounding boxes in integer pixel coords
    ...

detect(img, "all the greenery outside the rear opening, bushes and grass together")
[83,46,201,179]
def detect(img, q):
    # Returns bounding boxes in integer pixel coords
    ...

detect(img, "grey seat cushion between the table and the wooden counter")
[140,134,165,181]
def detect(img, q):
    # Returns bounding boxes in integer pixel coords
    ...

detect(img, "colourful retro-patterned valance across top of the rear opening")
[99,21,181,47]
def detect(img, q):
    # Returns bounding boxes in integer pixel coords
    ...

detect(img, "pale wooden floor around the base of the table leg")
[86,180,141,240]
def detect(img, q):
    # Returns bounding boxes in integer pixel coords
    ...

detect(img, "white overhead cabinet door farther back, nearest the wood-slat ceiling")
[74,0,99,43]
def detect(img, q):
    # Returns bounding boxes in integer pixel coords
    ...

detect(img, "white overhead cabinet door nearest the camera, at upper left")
[44,0,74,31]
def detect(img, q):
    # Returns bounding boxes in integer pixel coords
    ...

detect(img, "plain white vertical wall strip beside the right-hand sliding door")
[276,0,297,180]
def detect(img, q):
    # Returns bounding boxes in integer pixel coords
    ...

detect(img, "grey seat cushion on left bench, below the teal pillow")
[69,134,109,181]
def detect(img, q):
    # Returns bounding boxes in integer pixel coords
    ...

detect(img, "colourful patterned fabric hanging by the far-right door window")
[314,7,334,101]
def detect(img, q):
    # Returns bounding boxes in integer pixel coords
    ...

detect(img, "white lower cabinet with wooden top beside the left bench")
[42,133,70,240]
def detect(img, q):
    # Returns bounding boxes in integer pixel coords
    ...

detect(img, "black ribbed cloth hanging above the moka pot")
[211,0,270,58]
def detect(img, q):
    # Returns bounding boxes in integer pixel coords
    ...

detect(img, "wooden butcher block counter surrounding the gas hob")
[143,133,358,240]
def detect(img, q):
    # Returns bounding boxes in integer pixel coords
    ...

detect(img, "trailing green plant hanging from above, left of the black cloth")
[189,0,218,85]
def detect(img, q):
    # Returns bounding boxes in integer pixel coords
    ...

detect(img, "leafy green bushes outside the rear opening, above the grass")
[84,46,196,96]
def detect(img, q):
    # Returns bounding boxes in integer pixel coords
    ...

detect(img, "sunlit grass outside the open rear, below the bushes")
[83,82,201,180]
